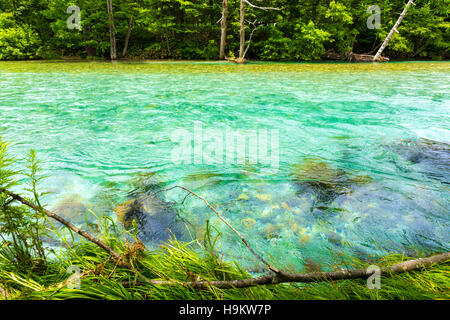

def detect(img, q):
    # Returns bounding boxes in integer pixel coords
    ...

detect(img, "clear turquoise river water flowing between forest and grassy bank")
[0,62,450,270]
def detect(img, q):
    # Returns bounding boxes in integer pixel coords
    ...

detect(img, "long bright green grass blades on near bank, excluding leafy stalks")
[0,212,450,300]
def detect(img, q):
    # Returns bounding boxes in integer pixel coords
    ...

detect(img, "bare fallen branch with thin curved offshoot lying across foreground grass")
[0,186,450,289]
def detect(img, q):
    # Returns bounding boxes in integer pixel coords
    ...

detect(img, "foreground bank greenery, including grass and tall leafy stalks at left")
[0,140,450,299]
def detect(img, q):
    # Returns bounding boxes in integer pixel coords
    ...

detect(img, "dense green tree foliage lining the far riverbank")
[0,0,450,61]
